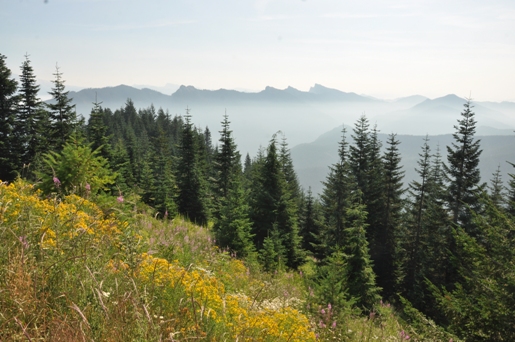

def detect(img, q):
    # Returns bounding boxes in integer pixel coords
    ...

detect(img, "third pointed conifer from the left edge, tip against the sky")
[46,65,77,150]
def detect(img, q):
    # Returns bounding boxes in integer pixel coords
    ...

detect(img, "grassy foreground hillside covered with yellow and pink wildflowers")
[0,180,456,341]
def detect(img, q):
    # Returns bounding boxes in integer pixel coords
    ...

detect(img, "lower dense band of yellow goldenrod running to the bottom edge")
[138,253,315,341]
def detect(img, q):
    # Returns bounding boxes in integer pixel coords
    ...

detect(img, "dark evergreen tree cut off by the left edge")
[0,54,21,181]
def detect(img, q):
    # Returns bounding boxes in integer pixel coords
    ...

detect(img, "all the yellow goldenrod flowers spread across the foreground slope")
[0,180,315,341]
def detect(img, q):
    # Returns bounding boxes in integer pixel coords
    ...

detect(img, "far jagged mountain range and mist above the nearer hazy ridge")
[61,84,515,155]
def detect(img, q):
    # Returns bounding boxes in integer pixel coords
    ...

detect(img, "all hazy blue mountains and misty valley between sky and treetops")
[52,84,515,192]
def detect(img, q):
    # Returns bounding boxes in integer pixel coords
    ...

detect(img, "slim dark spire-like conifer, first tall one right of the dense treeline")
[176,109,208,225]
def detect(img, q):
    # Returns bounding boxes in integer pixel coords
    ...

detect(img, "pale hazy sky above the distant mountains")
[0,0,515,101]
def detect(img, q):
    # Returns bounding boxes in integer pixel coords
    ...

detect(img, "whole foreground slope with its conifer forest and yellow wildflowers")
[0,54,515,342]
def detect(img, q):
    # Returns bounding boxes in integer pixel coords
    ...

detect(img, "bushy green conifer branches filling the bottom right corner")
[433,195,515,341]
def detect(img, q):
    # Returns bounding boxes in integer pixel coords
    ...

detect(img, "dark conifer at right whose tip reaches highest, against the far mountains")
[444,100,484,236]
